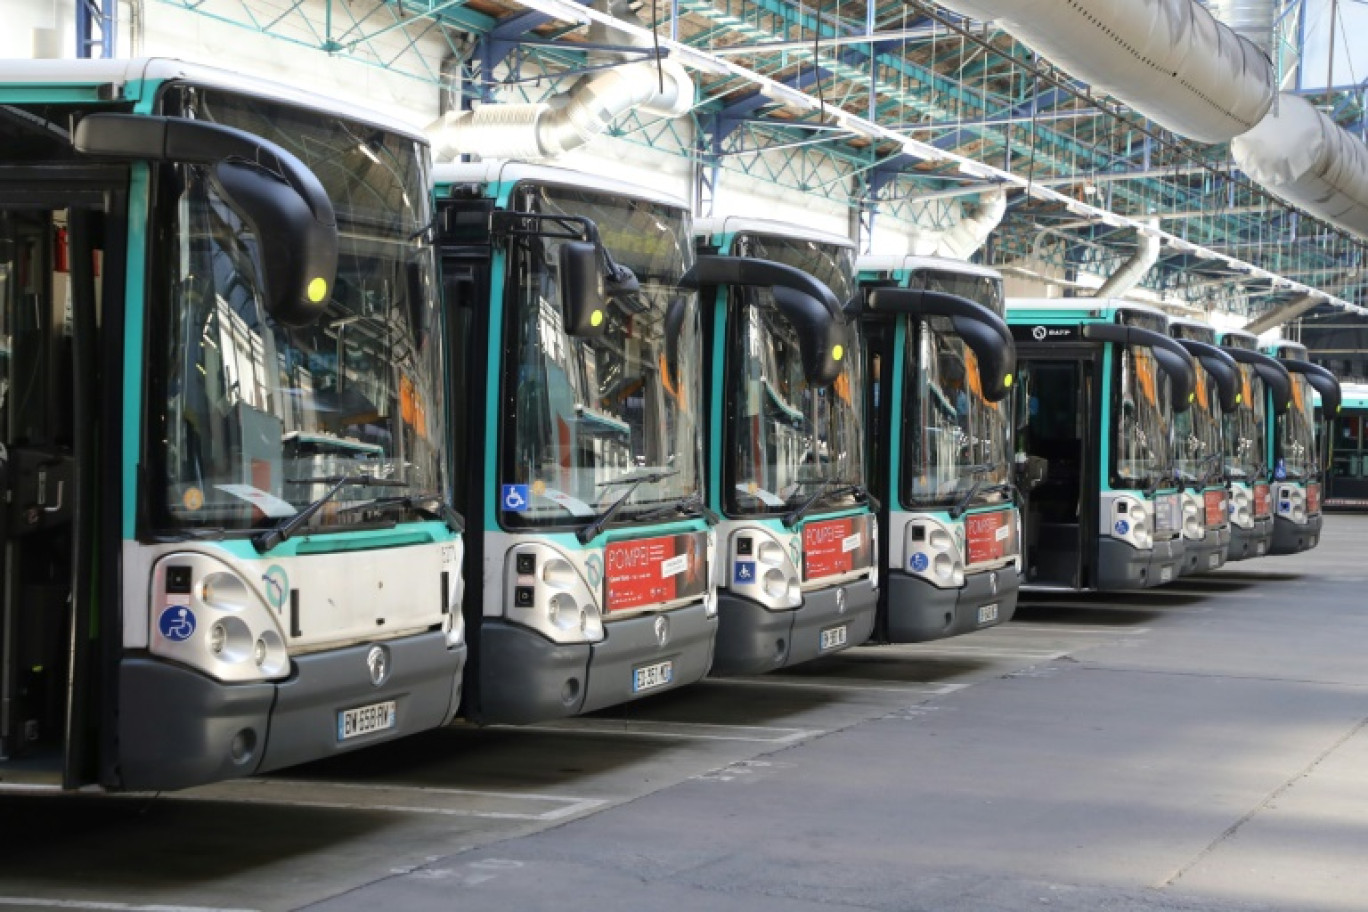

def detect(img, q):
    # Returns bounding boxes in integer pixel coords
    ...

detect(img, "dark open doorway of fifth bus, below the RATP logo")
[1016,346,1101,589]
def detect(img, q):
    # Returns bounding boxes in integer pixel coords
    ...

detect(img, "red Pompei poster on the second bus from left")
[603,532,707,611]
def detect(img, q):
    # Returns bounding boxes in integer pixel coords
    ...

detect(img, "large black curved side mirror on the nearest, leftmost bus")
[71,113,338,327]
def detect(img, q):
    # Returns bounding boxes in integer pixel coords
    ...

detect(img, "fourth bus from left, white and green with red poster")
[856,256,1021,643]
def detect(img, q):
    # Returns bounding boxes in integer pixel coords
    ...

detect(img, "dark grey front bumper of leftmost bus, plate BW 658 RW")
[118,632,465,790]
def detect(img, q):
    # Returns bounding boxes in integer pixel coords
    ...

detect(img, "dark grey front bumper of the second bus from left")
[473,604,717,725]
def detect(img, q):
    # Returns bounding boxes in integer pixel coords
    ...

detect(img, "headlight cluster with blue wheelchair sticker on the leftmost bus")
[149,552,290,682]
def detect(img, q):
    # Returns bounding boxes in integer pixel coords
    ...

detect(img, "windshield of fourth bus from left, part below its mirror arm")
[902,317,1011,507]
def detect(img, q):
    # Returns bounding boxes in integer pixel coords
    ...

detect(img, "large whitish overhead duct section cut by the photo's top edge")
[937,0,1276,142]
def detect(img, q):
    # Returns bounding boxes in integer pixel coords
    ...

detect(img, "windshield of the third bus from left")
[722,237,865,515]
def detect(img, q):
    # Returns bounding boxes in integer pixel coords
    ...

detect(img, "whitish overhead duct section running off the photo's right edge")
[1230,94,1368,237]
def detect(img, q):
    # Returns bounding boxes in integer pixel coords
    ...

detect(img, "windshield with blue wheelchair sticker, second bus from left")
[499,183,702,526]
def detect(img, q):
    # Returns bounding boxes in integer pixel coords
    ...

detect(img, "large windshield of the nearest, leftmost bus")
[146,86,447,531]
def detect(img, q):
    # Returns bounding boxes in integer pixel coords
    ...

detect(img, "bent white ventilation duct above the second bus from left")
[427,0,694,161]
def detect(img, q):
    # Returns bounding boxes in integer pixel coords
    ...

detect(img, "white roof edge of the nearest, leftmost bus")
[0,57,428,145]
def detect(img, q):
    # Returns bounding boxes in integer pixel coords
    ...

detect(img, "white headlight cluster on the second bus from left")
[505,543,603,643]
